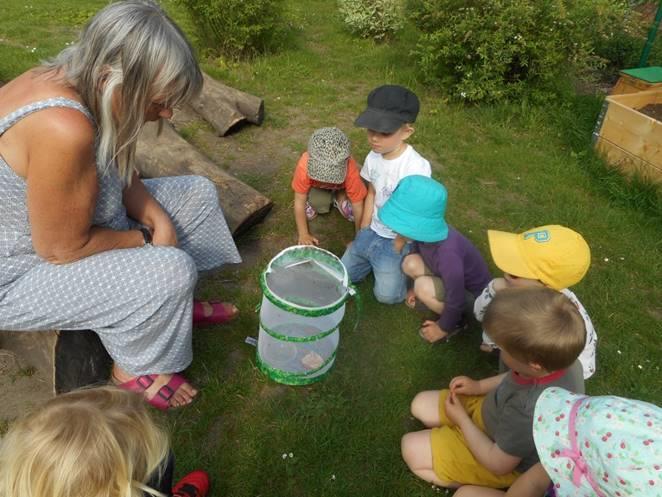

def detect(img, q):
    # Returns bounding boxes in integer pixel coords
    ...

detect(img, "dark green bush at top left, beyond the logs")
[180,0,285,58]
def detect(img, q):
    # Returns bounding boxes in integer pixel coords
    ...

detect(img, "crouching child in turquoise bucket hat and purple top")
[379,175,492,343]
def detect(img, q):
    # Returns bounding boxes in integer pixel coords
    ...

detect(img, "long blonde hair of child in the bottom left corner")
[0,387,169,497]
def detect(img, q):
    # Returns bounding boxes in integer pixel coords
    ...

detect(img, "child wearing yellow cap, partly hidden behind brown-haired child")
[474,225,598,379]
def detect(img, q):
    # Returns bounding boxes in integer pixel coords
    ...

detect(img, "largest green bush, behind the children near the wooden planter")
[408,0,629,102]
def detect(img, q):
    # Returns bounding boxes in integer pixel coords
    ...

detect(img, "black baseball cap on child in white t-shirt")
[354,85,420,133]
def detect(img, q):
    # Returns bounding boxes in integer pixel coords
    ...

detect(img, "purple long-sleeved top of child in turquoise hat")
[412,226,492,332]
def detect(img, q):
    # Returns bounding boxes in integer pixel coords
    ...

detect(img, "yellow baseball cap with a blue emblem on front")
[487,224,591,290]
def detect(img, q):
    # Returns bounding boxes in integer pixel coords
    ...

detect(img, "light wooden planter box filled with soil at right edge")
[593,88,662,184]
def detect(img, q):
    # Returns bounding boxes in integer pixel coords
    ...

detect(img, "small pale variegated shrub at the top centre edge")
[338,0,403,41]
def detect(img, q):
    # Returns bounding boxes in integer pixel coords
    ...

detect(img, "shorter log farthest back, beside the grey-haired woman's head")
[188,74,264,136]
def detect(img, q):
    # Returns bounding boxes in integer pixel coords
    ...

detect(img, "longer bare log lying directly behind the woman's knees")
[136,123,273,235]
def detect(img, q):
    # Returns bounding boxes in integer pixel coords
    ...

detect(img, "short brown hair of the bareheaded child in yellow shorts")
[483,287,586,372]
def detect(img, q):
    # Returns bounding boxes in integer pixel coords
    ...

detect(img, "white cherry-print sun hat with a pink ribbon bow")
[533,387,662,497]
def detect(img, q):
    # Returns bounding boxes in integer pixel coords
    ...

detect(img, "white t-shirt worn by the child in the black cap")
[361,145,432,238]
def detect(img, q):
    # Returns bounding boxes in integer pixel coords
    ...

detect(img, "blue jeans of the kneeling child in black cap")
[342,228,409,304]
